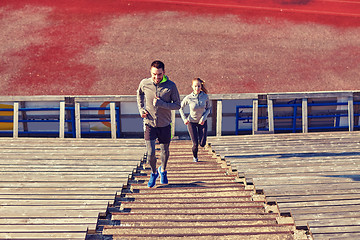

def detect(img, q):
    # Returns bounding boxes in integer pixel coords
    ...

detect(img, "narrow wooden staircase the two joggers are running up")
[99,141,295,240]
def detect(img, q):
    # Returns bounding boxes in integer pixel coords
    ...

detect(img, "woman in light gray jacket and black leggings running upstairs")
[179,78,211,162]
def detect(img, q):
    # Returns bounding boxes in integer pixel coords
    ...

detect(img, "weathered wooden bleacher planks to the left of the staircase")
[0,138,145,239]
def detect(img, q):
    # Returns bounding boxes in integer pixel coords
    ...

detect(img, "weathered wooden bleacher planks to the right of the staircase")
[209,132,360,239]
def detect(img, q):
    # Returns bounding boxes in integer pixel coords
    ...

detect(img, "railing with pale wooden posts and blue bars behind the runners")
[0,91,360,138]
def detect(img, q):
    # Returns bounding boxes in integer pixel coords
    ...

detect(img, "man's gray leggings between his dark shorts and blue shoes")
[145,140,170,173]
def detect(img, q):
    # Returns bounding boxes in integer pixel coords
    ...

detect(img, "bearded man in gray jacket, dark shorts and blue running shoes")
[137,61,180,188]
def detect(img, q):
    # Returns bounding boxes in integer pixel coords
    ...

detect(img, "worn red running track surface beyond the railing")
[0,0,360,95]
